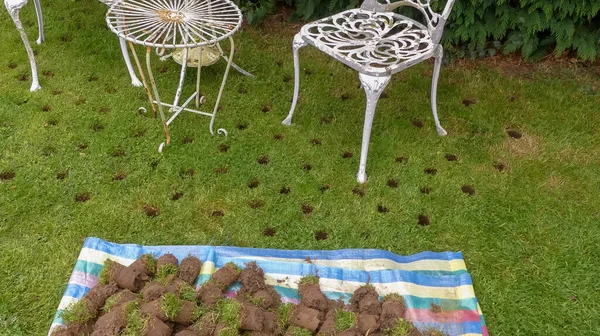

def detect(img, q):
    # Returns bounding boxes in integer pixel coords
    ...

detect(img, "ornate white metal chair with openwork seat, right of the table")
[283,0,455,183]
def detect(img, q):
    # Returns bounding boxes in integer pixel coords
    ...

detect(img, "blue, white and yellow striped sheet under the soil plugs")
[49,238,488,336]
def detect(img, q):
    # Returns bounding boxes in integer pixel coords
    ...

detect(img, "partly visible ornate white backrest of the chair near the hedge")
[360,0,456,44]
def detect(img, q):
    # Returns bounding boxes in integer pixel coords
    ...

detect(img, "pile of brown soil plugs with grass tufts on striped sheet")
[52,254,444,336]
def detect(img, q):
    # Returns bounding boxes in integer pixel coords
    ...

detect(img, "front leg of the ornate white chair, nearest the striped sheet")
[356,73,391,183]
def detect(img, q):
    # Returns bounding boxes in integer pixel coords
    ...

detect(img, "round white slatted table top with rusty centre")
[106,0,242,48]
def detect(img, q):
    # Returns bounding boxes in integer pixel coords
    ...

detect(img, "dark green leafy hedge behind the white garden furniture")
[236,0,600,60]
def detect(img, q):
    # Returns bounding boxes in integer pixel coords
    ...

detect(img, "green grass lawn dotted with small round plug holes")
[0,0,600,335]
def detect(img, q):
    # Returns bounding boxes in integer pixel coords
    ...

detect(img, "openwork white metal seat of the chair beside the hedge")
[301,9,435,76]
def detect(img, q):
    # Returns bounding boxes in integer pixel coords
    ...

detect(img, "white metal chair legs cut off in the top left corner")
[4,0,44,92]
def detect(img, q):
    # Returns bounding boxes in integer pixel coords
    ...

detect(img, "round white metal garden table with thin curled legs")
[106,0,242,152]
